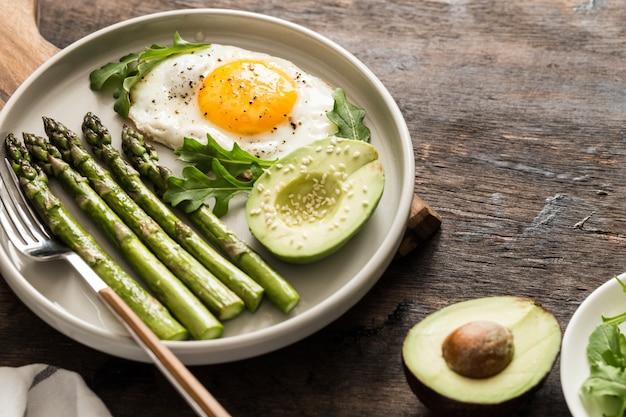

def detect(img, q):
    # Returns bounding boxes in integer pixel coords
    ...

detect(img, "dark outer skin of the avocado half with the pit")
[402,359,556,417]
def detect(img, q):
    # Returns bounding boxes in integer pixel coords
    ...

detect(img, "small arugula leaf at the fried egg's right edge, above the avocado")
[326,88,371,142]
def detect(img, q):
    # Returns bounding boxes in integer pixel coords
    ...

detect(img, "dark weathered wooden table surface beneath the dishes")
[0,0,626,417]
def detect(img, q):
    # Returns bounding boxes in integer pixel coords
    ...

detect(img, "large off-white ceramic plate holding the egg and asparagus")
[0,9,414,364]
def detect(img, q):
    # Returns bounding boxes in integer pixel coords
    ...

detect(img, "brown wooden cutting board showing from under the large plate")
[0,0,441,256]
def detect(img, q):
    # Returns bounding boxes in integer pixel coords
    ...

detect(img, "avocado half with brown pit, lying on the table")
[402,296,561,417]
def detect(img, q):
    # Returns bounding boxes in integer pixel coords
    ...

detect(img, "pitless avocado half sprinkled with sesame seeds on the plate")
[246,137,385,263]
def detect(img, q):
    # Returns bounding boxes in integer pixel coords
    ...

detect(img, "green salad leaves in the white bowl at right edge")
[581,278,626,417]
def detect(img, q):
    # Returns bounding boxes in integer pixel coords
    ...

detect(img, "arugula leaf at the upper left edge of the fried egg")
[89,32,209,117]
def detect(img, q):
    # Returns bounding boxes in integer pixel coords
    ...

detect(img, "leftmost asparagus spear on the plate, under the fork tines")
[5,133,189,340]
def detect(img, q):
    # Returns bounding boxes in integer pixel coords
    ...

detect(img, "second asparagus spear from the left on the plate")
[24,133,224,339]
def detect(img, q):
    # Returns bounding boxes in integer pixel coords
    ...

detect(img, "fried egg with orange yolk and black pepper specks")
[129,44,337,159]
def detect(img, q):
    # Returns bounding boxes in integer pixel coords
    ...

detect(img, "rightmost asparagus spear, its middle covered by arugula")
[122,128,300,313]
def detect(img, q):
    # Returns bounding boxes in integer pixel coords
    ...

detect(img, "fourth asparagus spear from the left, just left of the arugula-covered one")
[82,113,263,311]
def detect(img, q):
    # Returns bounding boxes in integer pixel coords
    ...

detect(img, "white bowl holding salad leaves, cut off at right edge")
[561,273,626,417]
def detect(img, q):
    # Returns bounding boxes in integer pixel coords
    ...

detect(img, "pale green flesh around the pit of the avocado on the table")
[402,296,561,415]
